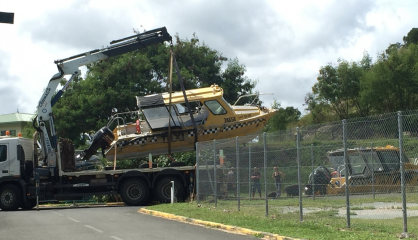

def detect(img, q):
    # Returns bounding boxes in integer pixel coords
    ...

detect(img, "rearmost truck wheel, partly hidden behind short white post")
[155,178,184,203]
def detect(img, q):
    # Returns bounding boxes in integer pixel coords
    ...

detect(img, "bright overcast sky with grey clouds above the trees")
[0,0,418,114]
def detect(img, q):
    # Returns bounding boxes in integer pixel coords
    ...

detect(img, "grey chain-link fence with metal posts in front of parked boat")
[196,111,418,233]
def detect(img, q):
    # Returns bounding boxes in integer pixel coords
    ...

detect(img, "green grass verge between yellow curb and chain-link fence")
[148,195,418,239]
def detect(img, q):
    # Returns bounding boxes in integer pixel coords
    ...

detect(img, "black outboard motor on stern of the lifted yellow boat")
[83,127,115,160]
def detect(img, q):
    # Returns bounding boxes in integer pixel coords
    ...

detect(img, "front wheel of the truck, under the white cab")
[0,184,22,211]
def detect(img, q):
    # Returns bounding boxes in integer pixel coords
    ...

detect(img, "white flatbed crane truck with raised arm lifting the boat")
[0,27,195,211]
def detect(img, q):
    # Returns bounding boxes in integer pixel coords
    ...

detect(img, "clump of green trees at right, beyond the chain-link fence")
[299,28,418,125]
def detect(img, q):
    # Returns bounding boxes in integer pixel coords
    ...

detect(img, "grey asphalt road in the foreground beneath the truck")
[0,206,256,240]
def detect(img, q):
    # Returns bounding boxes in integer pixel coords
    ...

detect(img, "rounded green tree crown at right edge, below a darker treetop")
[362,43,418,113]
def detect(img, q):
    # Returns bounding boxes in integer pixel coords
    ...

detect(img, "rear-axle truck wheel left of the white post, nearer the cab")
[120,179,149,206]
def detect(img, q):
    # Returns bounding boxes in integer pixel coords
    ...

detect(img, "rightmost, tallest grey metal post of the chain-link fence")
[398,111,408,235]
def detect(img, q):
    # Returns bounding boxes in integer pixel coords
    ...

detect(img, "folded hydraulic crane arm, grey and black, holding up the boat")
[36,27,172,166]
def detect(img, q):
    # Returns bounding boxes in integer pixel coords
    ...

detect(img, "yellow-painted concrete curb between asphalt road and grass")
[138,208,301,240]
